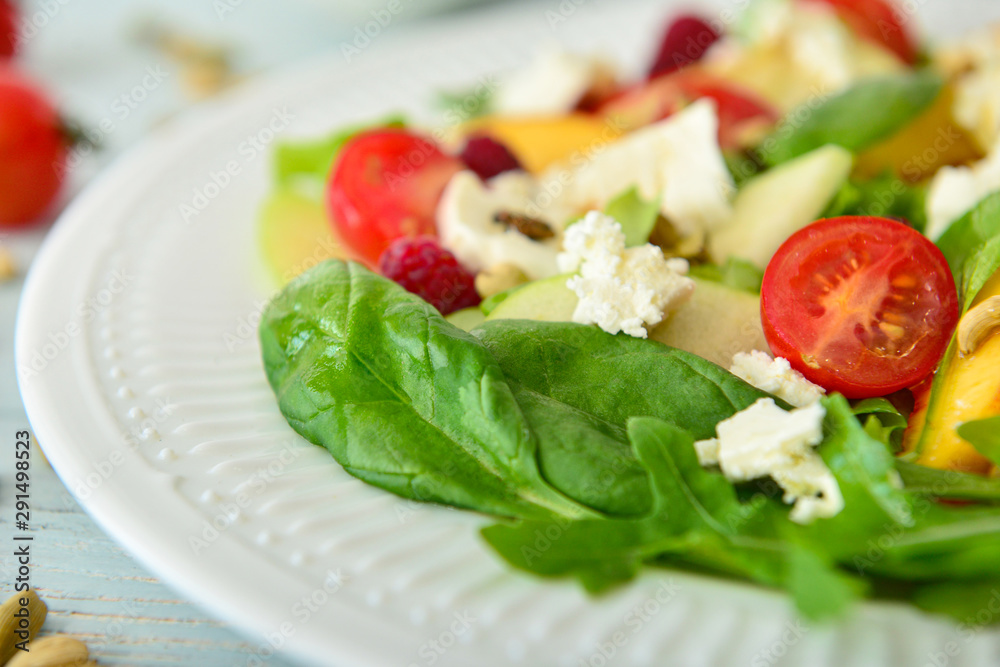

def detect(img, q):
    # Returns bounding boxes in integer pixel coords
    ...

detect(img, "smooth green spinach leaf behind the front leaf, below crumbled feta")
[472,320,767,439]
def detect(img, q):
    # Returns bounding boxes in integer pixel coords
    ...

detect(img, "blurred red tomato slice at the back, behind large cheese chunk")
[597,69,780,149]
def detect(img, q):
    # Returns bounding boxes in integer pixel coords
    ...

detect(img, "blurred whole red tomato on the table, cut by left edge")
[0,67,67,227]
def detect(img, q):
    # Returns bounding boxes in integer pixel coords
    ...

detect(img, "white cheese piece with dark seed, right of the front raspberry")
[437,171,573,280]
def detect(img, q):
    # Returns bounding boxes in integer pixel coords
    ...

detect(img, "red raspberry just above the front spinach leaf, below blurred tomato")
[378,236,480,315]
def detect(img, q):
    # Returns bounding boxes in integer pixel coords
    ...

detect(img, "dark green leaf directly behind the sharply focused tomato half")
[820,173,927,231]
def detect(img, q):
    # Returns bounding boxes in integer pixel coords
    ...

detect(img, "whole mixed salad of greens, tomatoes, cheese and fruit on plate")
[258,0,1000,621]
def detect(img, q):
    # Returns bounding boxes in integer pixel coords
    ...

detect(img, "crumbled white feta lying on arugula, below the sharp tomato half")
[695,398,844,523]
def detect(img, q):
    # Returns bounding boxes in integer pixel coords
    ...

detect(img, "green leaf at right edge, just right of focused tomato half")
[937,192,1000,312]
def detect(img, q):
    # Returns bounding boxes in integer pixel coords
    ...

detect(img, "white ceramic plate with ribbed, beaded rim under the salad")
[17,1,1000,667]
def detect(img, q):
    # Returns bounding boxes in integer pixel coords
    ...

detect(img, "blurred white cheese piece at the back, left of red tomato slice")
[493,50,614,115]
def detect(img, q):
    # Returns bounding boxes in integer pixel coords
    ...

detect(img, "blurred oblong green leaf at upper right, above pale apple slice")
[757,70,943,166]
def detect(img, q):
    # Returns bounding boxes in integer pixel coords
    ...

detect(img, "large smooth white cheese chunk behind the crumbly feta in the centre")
[541,99,735,237]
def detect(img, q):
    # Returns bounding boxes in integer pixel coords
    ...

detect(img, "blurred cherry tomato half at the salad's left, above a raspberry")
[326,129,462,267]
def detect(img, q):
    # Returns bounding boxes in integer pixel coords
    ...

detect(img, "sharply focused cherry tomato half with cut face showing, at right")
[761,216,959,398]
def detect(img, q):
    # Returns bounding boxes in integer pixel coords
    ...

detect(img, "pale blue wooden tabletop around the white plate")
[0,0,488,667]
